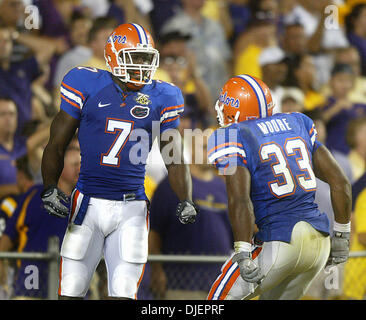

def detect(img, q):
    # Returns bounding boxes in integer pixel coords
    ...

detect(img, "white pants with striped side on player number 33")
[208,221,330,300]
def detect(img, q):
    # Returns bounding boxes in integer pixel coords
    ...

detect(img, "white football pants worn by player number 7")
[58,192,149,299]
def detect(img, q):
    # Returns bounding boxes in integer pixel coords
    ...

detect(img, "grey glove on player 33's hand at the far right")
[327,231,350,265]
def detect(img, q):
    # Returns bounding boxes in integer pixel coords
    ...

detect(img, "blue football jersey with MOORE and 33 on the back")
[208,113,329,242]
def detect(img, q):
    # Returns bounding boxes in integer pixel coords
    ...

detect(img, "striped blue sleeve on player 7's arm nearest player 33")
[160,84,184,133]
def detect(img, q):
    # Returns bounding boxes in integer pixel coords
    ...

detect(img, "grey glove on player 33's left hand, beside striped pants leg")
[232,251,264,284]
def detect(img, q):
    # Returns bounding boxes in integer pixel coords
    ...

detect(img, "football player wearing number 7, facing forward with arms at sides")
[42,23,197,299]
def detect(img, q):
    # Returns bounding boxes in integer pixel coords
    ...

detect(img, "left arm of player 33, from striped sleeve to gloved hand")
[208,127,263,283]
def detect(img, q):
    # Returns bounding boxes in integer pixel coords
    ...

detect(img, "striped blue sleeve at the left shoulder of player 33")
[207,127,247,174]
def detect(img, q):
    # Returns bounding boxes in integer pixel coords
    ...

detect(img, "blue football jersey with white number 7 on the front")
[60,67,184,200]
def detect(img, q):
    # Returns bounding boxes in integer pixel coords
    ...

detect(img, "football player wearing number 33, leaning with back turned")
[208,75,351,300]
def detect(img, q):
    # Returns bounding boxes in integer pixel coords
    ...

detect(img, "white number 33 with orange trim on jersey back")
[259,137,316,198]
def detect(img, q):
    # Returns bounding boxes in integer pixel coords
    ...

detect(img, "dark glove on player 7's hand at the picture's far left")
[41,186,70,218]
